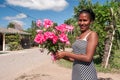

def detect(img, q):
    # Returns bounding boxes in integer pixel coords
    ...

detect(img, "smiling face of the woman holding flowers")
[78,13,91,32]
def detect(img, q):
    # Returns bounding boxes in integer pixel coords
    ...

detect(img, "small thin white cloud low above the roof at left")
[4,13,27,20]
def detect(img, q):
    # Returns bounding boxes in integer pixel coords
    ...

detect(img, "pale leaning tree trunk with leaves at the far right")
[102,2,120,68]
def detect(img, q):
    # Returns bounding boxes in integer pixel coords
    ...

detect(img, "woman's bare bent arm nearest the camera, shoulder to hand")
[56,32,98,62]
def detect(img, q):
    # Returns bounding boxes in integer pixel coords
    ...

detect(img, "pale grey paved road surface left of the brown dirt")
[0,48,50,80]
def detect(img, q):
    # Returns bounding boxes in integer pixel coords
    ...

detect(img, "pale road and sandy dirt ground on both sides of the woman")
[0,48,120,80]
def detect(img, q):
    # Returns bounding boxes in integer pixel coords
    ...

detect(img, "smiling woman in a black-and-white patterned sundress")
[56,9,98,80]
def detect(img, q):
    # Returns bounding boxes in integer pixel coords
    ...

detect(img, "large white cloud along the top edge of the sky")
[6,0,68,11]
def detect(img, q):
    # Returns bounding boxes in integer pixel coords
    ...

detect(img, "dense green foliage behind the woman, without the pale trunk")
[65,0,120,64]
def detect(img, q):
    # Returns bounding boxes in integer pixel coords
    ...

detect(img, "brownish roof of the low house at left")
[0,27,30,35]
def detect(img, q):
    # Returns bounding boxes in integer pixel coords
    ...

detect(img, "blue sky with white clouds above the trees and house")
[0,0,105,30]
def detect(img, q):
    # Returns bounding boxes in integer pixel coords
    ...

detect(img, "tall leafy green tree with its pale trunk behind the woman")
[66,0,120,68]
